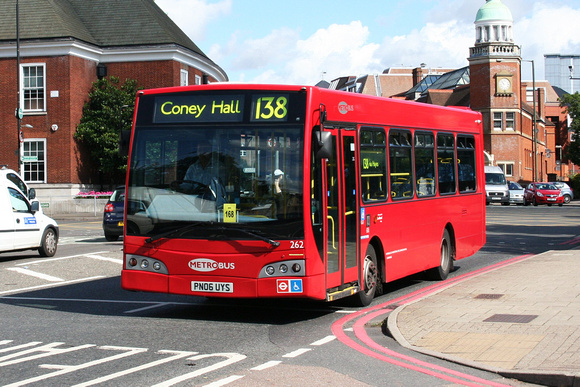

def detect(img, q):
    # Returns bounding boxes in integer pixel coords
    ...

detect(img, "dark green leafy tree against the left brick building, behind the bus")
[74,77,139,184]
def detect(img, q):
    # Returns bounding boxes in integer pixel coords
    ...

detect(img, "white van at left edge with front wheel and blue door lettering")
[0,174,59,257]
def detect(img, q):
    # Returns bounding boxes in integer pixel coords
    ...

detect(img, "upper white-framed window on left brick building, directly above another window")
[20,64,46,112]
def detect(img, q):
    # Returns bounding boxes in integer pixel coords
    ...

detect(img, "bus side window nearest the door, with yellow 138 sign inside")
[360,128,388,203]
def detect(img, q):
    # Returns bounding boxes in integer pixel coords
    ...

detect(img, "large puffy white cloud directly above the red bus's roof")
[215,21,381,84]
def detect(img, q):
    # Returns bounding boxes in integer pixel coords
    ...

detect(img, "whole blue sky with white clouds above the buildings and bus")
[155,0,580,85]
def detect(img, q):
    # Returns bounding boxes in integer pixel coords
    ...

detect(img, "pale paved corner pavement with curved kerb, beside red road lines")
[387,250,580,387]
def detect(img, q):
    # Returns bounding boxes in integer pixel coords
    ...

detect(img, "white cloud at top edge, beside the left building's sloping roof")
[155,0,232,42]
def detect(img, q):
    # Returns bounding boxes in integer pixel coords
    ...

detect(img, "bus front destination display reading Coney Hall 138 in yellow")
[153,94,289,124]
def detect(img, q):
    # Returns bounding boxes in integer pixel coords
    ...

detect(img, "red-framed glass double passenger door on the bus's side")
[323,129,360,300]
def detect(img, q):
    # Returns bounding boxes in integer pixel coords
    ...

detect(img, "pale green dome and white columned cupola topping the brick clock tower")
[475,0,514,45]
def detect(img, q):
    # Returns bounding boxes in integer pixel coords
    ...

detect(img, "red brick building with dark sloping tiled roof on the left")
[0,0,227,192]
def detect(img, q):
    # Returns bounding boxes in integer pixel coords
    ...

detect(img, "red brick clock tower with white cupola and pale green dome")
[468,0,525,165]
